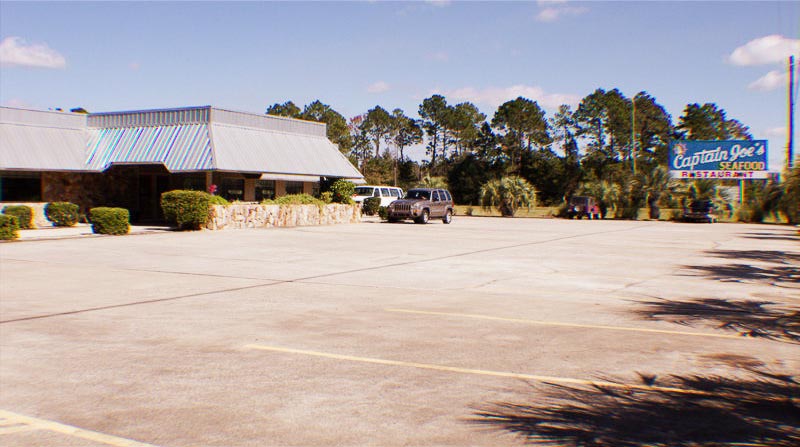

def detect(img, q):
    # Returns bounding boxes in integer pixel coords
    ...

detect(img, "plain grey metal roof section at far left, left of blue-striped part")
[0,107,89,171]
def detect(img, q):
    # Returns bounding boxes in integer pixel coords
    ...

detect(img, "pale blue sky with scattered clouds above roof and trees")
[0,0,800,170]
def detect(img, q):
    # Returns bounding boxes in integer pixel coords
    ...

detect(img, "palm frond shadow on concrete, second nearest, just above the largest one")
[636,298,800,343]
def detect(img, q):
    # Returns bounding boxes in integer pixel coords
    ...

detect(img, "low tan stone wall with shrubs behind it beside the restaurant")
[206,203,361,230]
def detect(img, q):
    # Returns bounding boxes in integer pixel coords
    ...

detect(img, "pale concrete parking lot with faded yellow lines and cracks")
[0,216,800,447]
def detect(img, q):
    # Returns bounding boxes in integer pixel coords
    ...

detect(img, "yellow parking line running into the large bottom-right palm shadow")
[245,344,707,395]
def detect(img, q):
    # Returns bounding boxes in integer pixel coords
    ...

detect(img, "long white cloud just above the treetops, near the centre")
[443,85,580,110]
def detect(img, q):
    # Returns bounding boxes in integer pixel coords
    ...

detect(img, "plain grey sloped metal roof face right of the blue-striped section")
[211,124,363,178]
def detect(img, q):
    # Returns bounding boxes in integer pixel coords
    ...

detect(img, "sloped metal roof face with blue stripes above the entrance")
[86,124,212,172]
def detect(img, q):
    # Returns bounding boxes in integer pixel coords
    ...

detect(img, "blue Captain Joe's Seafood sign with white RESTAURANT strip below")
[669,140,768,180]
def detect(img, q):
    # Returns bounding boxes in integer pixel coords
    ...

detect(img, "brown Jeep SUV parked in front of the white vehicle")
[387,188,454,224]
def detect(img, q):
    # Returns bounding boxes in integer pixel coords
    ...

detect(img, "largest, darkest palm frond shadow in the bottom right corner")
[476,371,800,447]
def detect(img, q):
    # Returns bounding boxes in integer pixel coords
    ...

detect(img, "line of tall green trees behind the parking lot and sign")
[266,88,800,224]
